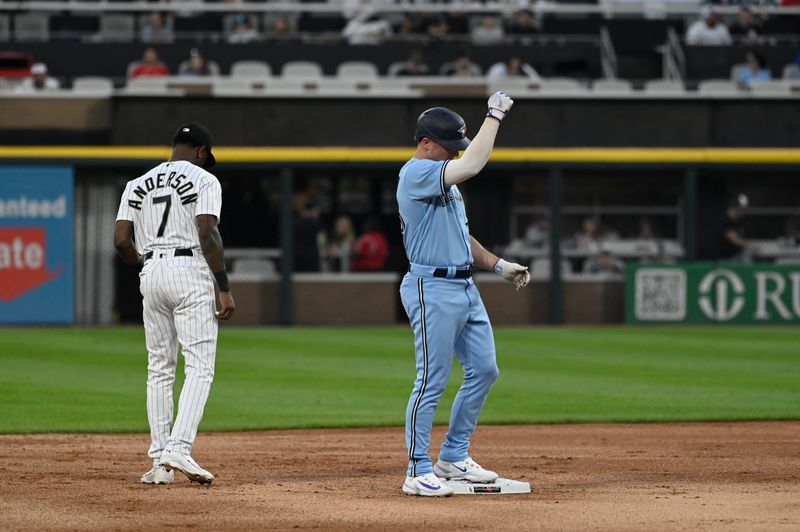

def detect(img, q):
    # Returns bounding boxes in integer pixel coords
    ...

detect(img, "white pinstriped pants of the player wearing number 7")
[139,252,218,462]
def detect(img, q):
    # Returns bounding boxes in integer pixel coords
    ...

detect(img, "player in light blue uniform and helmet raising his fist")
[397,92,530,497]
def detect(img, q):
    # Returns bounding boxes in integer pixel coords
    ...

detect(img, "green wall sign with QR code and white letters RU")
[625,263,800,324]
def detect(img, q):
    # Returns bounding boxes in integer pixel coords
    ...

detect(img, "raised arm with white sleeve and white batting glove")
[444,92,514,185]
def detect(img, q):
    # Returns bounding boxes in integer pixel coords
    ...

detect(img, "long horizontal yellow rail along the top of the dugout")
[0,146,800,164]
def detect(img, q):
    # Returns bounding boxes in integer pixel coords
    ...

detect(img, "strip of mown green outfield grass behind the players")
[0,327,800,433]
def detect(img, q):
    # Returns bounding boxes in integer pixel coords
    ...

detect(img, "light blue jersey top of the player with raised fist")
[397,158,473,267]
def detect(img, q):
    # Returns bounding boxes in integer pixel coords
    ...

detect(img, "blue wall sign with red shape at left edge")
[0,166,75,323]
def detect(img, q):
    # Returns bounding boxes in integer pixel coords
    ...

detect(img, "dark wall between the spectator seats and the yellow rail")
[0,96,800,147]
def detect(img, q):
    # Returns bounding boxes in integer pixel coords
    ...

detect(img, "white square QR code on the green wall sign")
[635,268,686,321]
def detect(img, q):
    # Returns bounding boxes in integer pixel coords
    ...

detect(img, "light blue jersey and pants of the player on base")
[397,158,499,477]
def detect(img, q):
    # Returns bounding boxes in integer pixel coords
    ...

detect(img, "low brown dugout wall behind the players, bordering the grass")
[231,273,624,325]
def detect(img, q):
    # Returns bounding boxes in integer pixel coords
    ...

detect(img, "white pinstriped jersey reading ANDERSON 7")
[117,161,222,255]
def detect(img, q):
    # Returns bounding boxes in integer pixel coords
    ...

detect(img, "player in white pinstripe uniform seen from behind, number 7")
[114,123,235,484]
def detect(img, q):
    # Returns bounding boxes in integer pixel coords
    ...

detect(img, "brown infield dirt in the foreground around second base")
[0,422,800,531]
